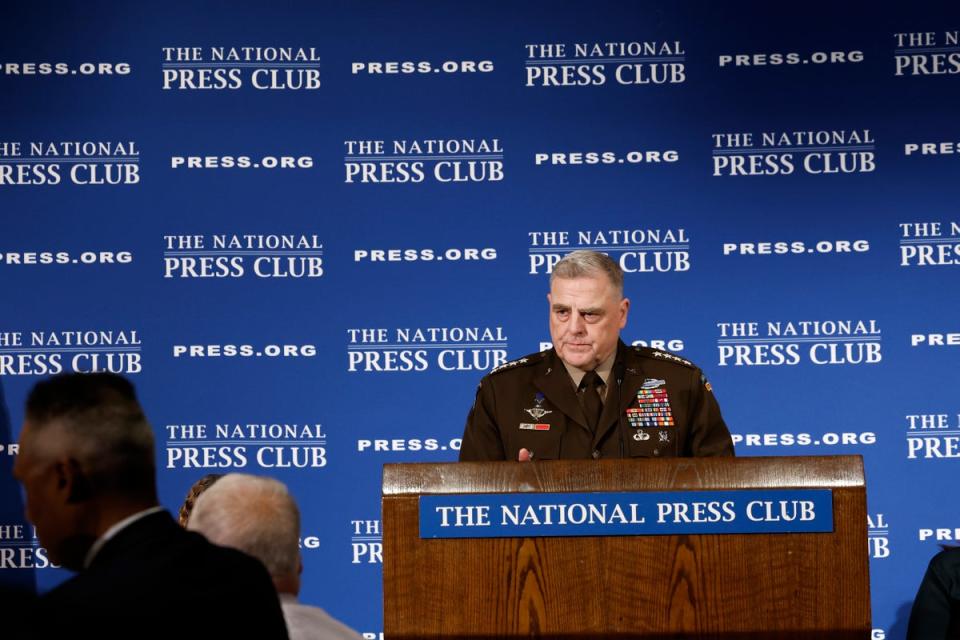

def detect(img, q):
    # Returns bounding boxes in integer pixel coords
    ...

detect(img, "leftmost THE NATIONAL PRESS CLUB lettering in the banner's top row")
[161,46,320,91]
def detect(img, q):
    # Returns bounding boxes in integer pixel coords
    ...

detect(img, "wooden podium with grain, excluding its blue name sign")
[382,456,871,640]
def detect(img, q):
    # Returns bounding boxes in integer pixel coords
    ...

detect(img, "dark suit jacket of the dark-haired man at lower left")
[34,511,287,640]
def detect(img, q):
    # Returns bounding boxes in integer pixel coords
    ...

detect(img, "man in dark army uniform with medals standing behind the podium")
[460,251,733,462]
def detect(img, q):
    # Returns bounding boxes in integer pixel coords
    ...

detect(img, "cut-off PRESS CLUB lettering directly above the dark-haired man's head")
[0,329,143,376]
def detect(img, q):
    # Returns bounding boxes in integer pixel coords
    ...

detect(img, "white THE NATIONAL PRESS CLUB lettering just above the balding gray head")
[164,422,328,470]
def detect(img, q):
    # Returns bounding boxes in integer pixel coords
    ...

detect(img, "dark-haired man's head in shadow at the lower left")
[14,373,157,570]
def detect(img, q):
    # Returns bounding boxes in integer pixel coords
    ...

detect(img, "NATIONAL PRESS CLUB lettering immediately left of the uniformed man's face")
[347,327,508,373]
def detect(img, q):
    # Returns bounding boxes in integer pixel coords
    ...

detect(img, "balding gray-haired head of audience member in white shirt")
[187,473,300,577]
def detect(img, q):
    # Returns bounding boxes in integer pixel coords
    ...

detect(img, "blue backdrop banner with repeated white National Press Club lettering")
[0,0,960,638]
